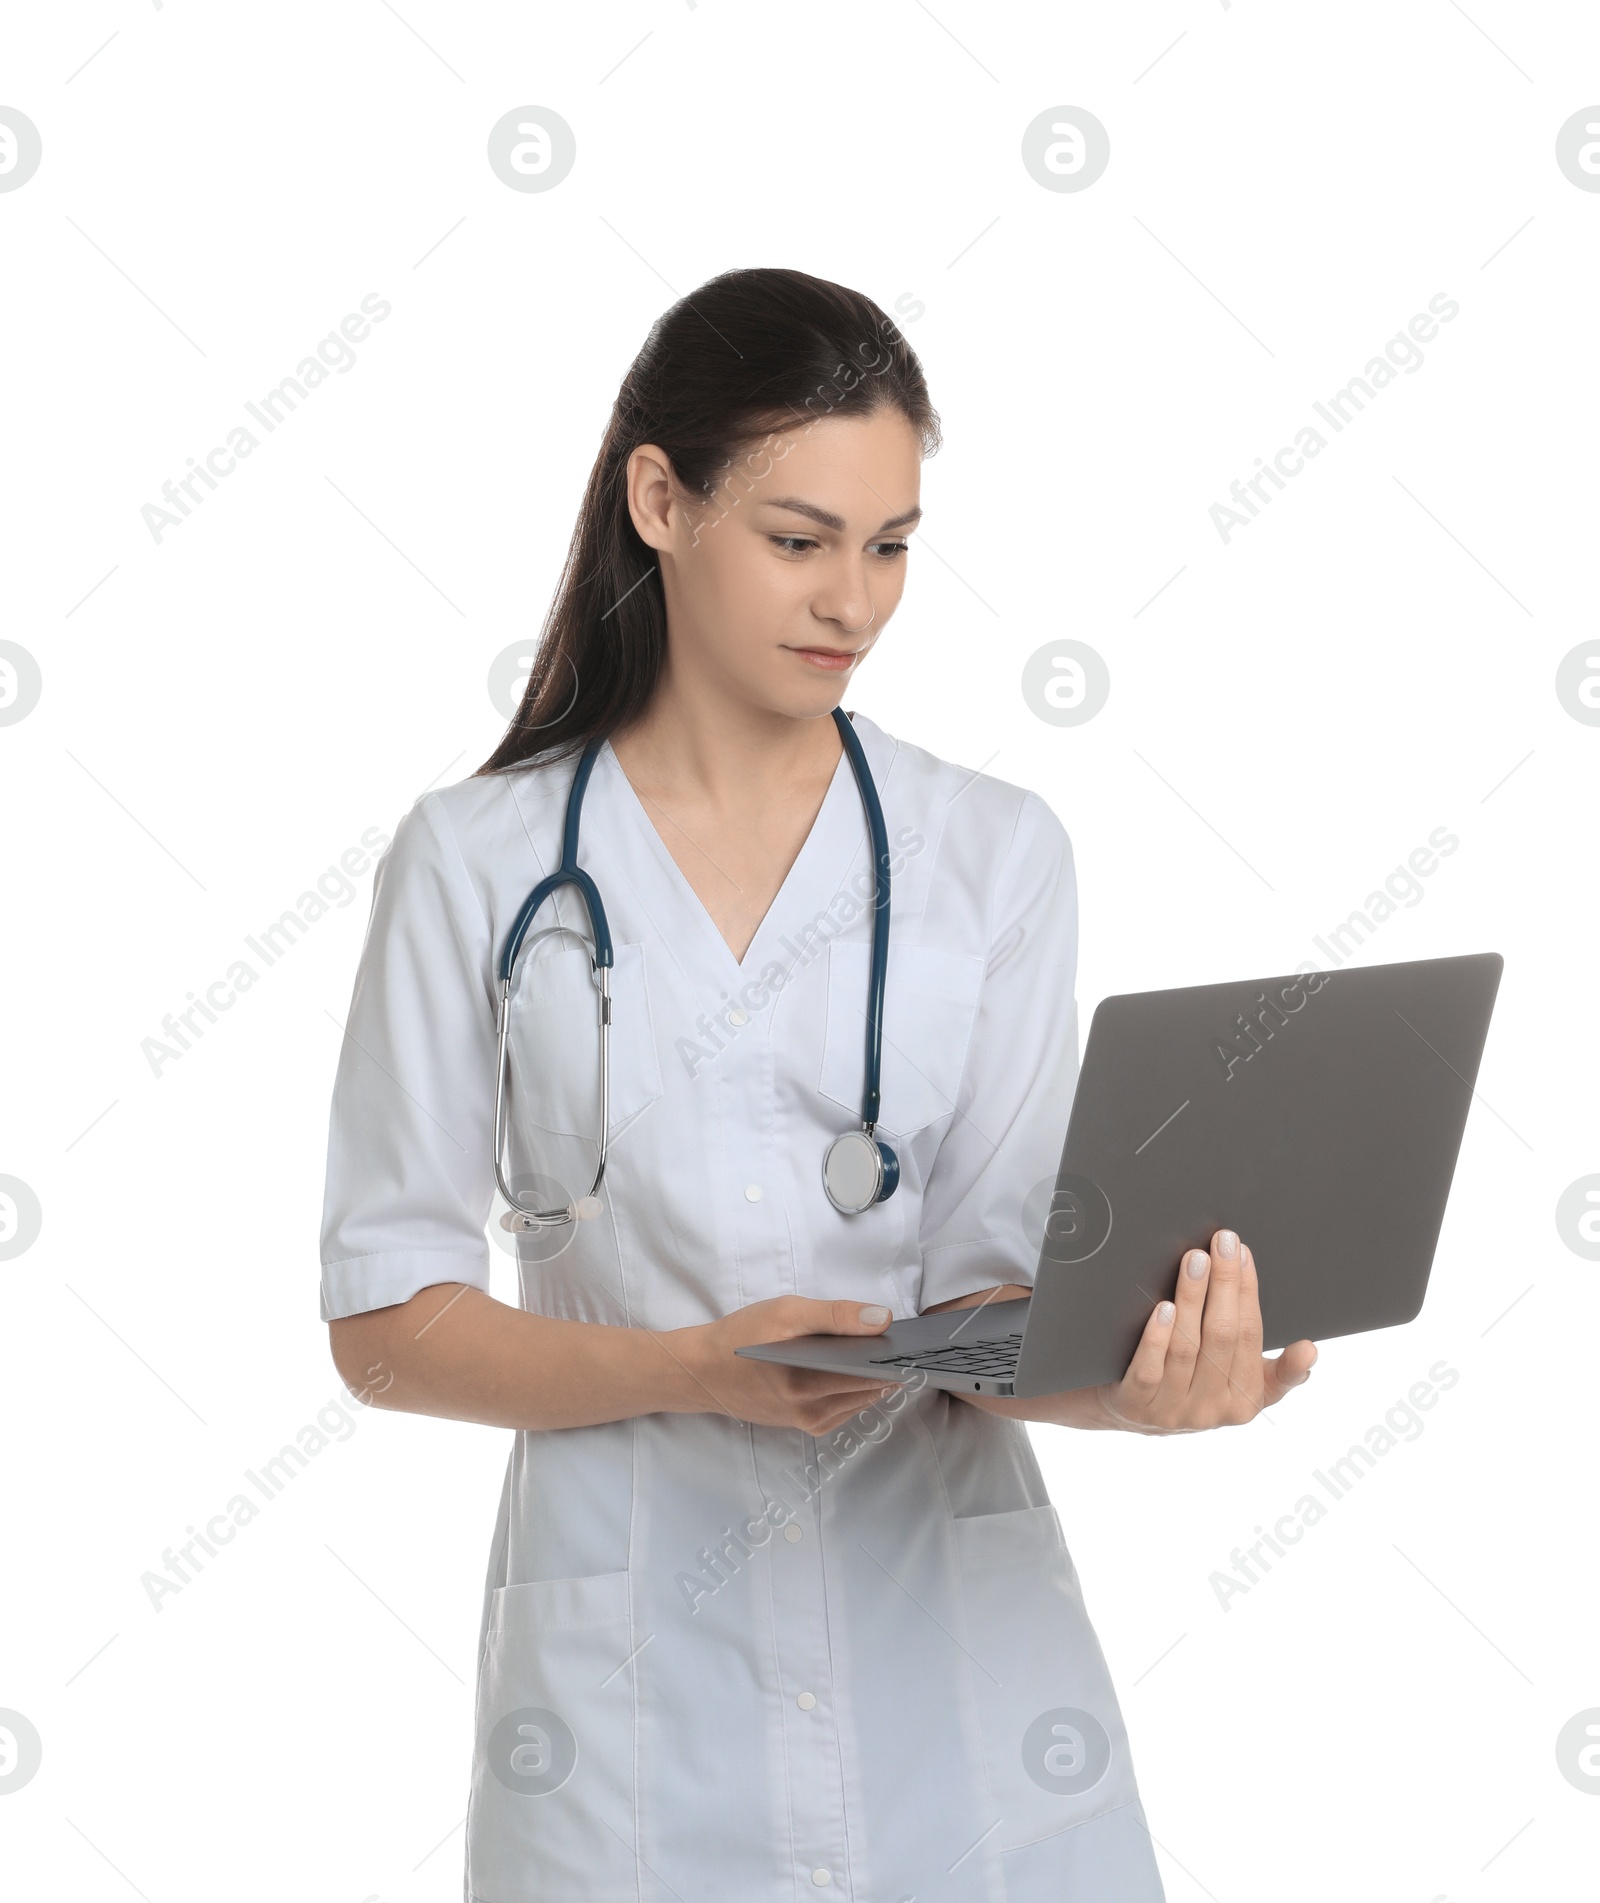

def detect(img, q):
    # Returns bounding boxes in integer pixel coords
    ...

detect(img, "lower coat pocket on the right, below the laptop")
[953,1505,1138,1850]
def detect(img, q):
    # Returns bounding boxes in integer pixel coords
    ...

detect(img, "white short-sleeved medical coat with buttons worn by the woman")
[322,717,1162,1903]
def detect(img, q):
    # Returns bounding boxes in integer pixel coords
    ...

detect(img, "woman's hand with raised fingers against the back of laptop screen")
[1095,1229,1317,1433]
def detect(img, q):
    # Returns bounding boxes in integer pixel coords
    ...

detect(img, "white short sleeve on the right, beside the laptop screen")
[921,794,1079,1311]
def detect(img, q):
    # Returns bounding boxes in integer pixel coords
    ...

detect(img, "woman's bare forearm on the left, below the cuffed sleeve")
[329,1283,715,1429]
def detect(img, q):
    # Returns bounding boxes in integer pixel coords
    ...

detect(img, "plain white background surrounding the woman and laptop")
[0,0,1600,1903]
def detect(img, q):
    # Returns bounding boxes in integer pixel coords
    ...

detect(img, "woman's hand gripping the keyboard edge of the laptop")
[654,1296,900,1435]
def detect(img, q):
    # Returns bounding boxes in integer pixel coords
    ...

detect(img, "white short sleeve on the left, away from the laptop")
[322,794,497,1321]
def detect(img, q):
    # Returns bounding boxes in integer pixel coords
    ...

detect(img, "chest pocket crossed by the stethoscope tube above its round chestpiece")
[818,938,984,1136]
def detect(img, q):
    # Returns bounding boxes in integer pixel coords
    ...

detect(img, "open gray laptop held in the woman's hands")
[738,952,1503,1395]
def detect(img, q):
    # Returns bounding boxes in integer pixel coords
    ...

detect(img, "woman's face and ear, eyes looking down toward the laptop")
[628,409,923,719]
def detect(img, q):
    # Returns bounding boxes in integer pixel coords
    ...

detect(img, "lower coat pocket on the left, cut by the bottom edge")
[466,1572,639,1903]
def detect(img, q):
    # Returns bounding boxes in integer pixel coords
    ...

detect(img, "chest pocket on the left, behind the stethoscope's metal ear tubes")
[506,936,662,1134]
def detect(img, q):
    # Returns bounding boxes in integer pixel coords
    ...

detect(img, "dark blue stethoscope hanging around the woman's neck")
[495,708,900,1231]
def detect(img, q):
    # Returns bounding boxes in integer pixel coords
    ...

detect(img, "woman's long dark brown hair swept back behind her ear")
[478,270,940,773]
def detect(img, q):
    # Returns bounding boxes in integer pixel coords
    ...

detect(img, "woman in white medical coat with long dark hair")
[322,270,1315,1903]
